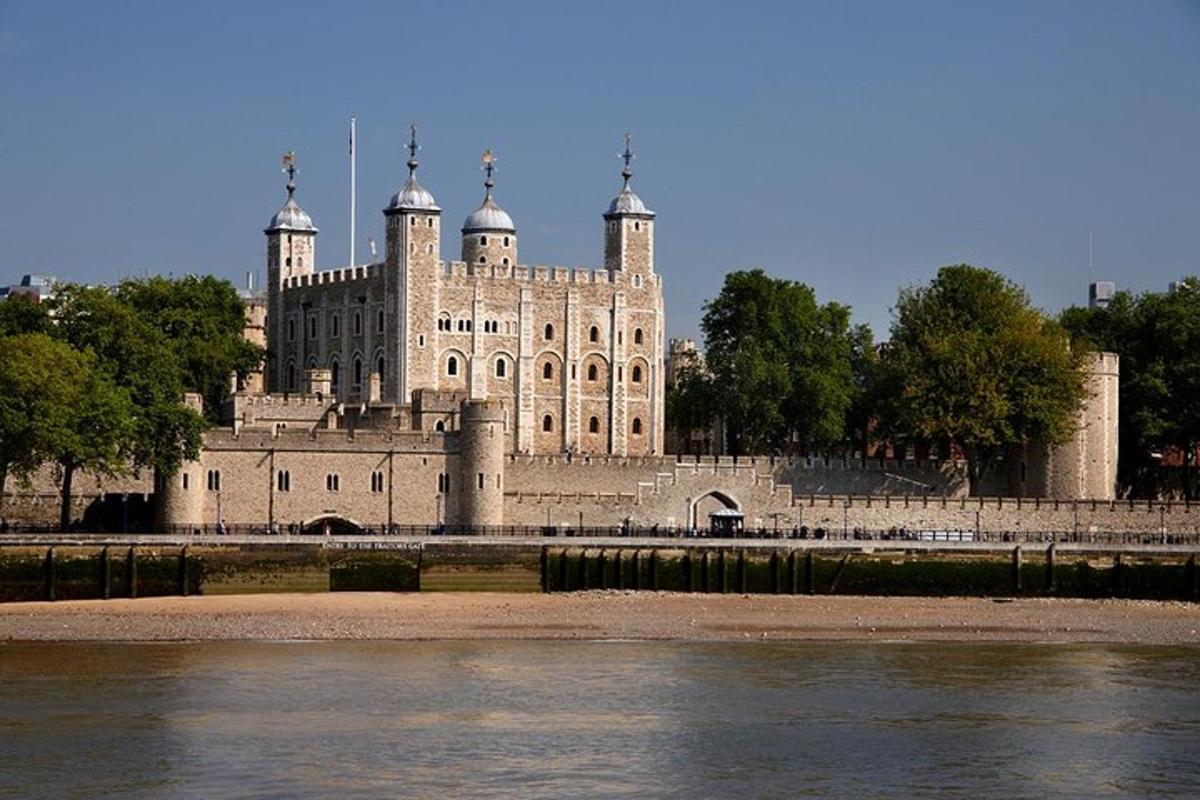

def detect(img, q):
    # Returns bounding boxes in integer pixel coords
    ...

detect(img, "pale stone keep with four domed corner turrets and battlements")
[264,130,664,456]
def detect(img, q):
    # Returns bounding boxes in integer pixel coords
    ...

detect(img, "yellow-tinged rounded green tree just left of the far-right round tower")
[882,264,1086,495]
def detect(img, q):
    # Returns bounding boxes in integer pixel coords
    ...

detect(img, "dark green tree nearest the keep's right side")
[701,270,853,455]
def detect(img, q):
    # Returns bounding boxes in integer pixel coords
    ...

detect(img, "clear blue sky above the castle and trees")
[0,0,1200,336]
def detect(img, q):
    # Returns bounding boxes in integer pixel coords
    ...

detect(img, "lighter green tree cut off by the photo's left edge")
[0,333,88,516]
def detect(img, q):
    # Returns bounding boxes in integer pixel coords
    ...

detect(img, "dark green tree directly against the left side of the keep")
[116,275,263,422]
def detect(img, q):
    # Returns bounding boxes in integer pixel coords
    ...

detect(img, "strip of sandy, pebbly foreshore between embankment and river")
[0,591,1200,644]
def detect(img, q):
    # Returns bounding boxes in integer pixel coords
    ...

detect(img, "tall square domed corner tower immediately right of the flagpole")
[382,125,442,403]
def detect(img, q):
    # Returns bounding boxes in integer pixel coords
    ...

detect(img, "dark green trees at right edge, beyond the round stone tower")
[1062,277,1200,498]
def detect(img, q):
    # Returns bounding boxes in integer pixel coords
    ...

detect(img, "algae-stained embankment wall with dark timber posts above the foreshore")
[0,536,1200,602]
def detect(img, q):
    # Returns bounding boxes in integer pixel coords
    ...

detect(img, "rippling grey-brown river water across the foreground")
[0,642,1200,799]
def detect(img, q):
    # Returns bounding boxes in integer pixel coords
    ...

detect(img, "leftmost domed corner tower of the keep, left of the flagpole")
[263,150,317,392]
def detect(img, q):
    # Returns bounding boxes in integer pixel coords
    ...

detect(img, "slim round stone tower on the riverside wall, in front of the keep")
[457,401,504,527]
